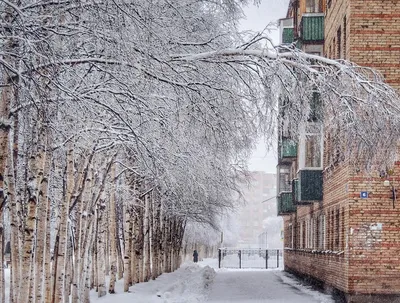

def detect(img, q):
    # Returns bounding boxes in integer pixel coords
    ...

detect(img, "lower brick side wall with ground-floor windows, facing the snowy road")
[284,166,349,292]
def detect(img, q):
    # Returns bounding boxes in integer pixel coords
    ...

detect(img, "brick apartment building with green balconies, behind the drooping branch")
[277,0,400,303]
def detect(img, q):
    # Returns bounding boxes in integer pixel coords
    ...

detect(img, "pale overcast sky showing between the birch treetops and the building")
[241,0,289,173]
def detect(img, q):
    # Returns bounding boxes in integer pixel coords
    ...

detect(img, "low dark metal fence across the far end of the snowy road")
[218,248,283,269]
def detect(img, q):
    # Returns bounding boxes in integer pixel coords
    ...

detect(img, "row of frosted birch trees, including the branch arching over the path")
[0,0,400,303]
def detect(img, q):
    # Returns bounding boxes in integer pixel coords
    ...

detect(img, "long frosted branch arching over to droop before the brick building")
[171,39,400,169]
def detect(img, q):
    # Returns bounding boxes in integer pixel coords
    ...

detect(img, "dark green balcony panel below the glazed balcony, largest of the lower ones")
[297,169,323,204]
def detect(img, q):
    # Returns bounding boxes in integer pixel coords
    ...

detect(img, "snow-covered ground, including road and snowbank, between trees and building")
[6,259,334,303]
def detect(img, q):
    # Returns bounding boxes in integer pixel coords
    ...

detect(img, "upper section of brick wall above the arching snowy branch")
[324,0,400,89]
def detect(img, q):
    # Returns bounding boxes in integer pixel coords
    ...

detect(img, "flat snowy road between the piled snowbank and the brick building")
[207,270,334,303]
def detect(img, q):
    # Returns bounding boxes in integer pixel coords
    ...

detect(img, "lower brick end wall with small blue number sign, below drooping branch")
[349,162,400,294]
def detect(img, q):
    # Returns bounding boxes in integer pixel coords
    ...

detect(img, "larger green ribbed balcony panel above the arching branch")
[300,14,324,42]
